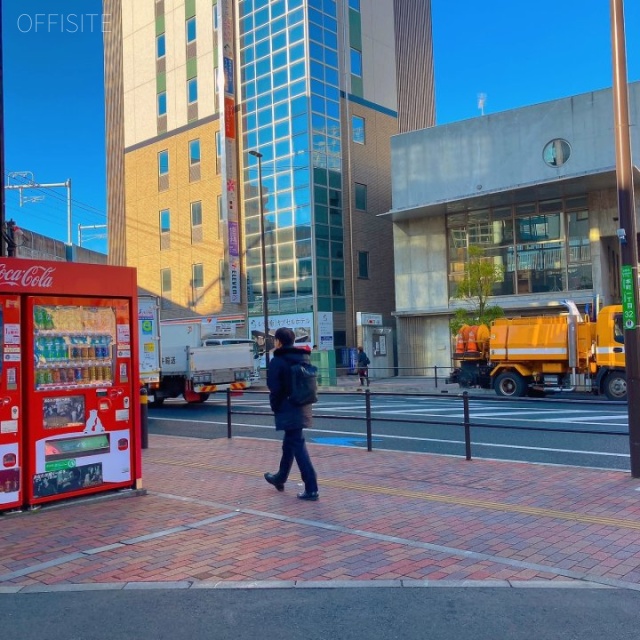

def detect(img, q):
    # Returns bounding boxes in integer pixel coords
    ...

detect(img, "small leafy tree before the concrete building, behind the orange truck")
[450,245,504,335]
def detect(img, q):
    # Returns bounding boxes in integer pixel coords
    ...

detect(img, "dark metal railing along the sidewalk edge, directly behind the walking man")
[227,389,629,460]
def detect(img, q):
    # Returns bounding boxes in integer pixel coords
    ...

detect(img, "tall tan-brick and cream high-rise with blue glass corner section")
[104,0,434,348]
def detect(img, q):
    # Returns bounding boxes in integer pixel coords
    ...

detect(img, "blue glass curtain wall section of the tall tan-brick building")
[238,0,345,315]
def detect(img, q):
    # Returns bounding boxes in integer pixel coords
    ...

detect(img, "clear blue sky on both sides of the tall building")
[1,0,640,251]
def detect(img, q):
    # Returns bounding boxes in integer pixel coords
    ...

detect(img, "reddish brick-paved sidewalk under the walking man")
[0,436,640,593]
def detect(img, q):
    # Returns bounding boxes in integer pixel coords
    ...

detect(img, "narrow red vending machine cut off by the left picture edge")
[0,294,24,511]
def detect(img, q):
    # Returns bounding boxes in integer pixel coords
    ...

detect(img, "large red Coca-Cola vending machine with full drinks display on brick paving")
[0,258,141,508]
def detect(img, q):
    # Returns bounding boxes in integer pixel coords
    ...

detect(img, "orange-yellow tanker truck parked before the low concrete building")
[450,300,627,400]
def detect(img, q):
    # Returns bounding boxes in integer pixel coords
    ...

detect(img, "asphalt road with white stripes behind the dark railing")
[149,393,629,470]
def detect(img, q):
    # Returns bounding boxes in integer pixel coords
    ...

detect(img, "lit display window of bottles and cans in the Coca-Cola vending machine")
[33,305,116,391]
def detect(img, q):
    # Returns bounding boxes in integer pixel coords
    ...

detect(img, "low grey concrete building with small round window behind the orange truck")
[384,83,640,372]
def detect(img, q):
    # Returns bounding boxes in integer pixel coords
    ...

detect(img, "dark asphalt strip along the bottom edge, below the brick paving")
[0,587,640,640]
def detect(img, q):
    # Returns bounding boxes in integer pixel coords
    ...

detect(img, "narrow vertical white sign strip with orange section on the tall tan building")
[217,0,242,303]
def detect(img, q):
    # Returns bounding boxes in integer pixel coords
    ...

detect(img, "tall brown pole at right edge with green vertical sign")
[611,0,640,478]
